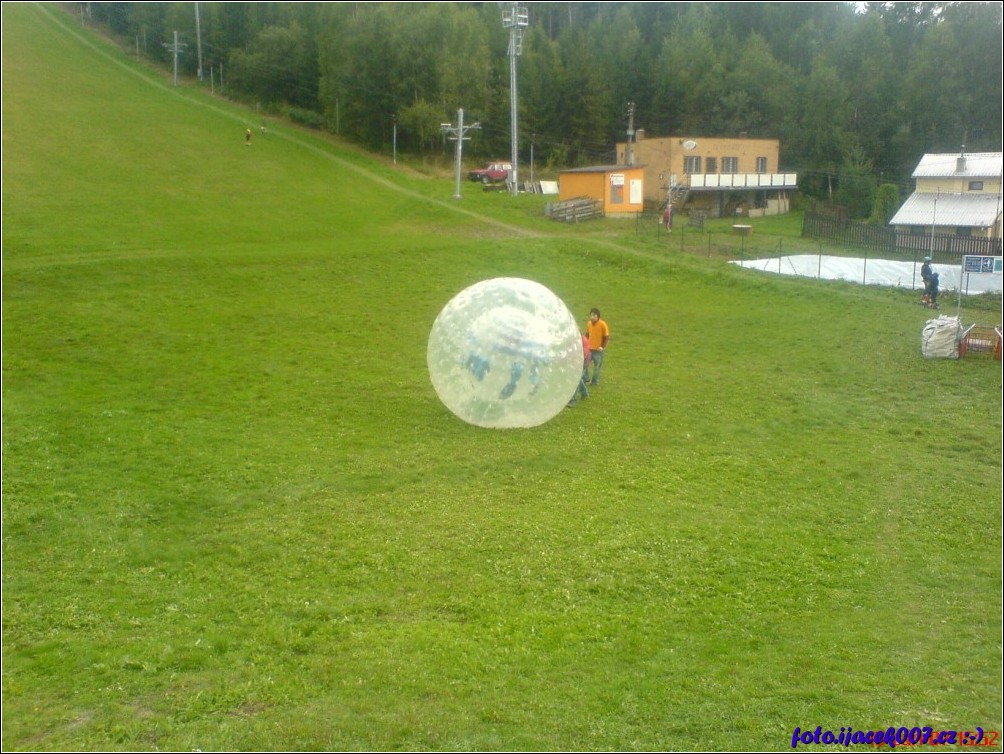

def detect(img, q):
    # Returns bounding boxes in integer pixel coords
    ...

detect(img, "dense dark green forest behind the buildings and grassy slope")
[86,2,1002,214]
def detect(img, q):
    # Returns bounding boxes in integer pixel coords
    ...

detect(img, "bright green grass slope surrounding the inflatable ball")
[2,3,1002,751]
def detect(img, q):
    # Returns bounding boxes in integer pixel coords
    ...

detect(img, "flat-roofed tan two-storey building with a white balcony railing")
[617,131,798,217]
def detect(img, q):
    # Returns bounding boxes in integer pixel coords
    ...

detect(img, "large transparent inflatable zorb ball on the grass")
[428,277,582,428]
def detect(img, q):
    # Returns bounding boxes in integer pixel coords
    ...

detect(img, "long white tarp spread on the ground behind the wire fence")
[733,254,1004,294]
